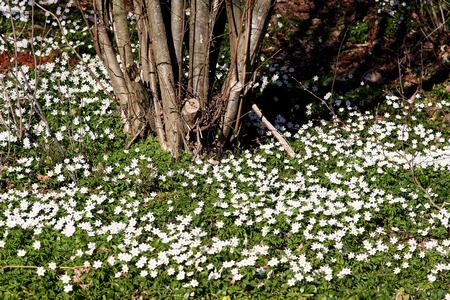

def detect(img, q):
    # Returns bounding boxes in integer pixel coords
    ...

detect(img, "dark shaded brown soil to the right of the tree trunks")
[244,0,450,140]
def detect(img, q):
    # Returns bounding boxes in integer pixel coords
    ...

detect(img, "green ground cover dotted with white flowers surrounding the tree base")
[0,0,450,299]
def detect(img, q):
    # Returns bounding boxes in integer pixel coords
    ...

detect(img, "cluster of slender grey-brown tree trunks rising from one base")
[93,0,275,157]
